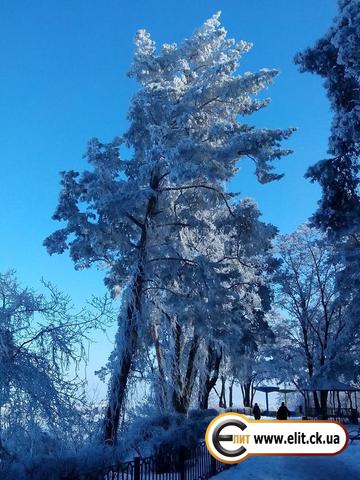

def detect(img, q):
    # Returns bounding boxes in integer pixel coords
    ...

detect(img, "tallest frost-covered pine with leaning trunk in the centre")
[45,14,293,444]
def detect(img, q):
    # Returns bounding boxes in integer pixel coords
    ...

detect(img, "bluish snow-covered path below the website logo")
[214,442,360,480]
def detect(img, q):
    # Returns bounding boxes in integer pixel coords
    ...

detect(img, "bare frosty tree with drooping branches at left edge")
[0,272,111,450]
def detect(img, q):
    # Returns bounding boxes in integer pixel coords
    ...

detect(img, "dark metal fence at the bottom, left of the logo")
[90,442,230,480]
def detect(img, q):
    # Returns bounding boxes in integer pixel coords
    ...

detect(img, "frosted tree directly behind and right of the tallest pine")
[191,199,277,408]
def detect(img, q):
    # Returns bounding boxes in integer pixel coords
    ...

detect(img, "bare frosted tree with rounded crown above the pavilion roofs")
[274,226,359,413]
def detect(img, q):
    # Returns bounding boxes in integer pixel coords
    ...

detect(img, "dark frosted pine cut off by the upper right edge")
[295,0,360,352]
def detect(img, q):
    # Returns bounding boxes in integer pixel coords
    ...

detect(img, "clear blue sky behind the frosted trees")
[0,0,336,396]
